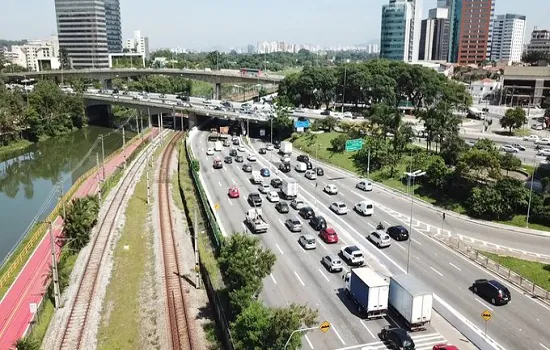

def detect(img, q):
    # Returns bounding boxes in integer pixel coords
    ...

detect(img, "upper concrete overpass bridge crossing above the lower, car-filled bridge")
[4,68,284,99]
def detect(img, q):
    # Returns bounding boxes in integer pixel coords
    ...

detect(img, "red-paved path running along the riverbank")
[0,129,158,350]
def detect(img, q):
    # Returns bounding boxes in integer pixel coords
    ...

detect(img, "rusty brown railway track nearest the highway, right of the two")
[158,134,199,350]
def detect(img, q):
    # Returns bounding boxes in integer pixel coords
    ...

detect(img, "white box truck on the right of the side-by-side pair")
[389,275,433,331]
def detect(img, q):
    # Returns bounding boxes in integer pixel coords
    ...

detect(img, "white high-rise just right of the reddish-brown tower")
[491,13,525,64]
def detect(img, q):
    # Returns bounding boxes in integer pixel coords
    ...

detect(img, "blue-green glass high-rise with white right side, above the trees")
[380,0,422,62]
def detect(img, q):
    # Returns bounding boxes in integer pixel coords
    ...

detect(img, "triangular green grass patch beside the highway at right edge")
[481,252,550,290]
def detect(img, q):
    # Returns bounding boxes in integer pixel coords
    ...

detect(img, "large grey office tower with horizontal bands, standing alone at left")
[55,0,109,69]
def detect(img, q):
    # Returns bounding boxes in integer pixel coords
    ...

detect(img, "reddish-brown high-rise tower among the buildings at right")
[449,0,495,64]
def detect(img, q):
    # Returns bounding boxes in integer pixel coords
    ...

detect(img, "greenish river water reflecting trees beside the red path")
[0,126,135,262]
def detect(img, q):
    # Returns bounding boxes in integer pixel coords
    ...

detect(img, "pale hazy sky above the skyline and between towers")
[0,0,550,49]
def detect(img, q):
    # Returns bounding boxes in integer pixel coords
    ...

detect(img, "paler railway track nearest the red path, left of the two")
[56,130,166,350]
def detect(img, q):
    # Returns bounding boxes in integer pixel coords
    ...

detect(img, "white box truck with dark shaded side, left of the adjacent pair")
[344,267,390,319]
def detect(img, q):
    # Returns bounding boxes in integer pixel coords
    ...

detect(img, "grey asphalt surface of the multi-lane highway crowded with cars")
[192,129,550,350]
